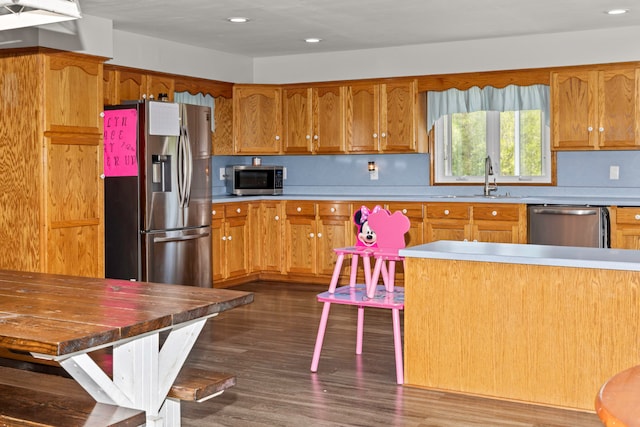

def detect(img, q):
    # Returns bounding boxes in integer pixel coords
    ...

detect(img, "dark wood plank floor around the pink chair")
[182,283,602,427]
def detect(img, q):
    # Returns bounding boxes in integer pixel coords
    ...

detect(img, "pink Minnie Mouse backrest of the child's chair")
[353,206,411,249]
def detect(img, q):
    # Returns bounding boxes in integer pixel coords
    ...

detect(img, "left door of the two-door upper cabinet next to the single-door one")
[282,88,313,154]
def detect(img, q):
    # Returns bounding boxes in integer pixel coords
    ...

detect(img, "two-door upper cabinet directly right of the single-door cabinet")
[282,86,346,154]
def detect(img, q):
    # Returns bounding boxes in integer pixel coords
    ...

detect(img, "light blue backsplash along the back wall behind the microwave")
[211,151,640,197]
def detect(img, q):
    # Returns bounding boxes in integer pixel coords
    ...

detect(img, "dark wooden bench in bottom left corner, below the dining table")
[0,367,146,427]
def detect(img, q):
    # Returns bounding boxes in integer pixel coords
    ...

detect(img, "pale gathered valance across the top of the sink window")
[427,85,550,130]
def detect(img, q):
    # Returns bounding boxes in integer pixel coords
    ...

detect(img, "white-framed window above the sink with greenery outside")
[429,86,551,183]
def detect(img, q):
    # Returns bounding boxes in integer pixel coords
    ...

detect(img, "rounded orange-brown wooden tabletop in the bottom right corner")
[596,366,640,427]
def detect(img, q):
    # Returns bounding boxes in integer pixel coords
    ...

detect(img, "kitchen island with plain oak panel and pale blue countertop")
[400,241,640,411]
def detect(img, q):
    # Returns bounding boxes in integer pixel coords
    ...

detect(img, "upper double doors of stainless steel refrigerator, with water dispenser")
[143,101,211,231]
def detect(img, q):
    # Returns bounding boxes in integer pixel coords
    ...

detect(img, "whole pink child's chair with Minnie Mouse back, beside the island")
[311,206,410,384]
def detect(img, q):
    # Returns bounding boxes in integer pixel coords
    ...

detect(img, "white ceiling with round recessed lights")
[79,0,640,57]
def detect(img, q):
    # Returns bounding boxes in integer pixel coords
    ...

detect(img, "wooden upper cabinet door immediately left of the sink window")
[380,80,417,152]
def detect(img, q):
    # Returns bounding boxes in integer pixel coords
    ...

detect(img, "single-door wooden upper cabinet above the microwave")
[233,85,282,154]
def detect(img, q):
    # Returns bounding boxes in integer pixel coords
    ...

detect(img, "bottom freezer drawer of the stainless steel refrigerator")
[143,227,212,288]
